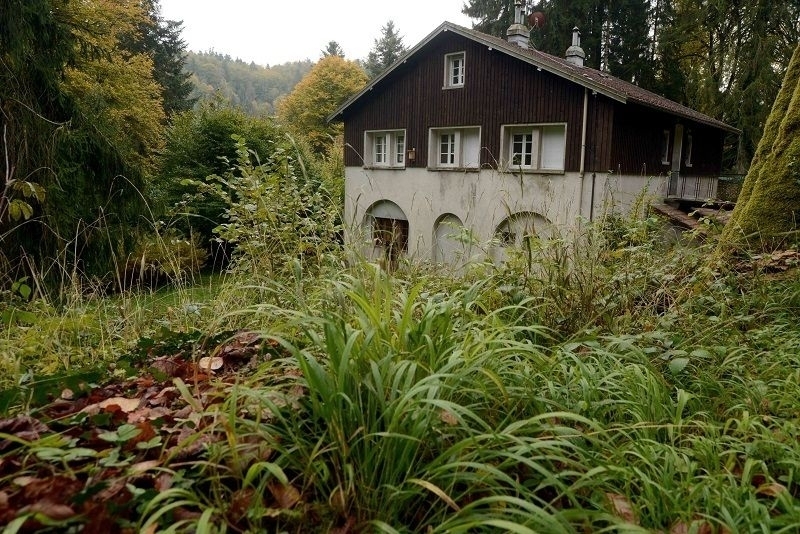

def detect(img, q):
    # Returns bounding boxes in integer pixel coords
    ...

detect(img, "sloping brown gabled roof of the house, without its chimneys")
[328,22,739,133]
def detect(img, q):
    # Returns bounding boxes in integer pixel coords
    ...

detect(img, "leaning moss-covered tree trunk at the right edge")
[722,44,800,250]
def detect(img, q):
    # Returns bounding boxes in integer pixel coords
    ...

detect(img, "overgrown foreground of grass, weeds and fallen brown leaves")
[0,194,800,533]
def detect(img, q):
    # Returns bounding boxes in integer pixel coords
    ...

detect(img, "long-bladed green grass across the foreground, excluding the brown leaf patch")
[1,211,800,532]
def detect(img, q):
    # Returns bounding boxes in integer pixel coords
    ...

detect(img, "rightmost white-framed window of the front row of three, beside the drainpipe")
[501,124,567,172]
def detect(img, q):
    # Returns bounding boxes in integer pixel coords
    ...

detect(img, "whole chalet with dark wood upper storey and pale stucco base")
[329,9,737,263]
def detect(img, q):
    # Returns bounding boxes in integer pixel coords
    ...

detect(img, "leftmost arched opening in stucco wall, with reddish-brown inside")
[364,200,408,269]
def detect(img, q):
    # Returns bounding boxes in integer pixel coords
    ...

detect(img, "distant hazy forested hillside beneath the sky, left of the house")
[186,51,313,116]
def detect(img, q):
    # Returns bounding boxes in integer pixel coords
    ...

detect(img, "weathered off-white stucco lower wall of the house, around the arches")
[344,167,666,260]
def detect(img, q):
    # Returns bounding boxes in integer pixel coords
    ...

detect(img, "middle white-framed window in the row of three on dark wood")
[428,126,481,169]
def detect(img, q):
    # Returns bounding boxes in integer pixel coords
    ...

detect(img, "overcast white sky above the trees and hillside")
[161,0,472,65]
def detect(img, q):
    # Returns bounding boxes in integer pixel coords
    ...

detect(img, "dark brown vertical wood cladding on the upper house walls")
[338,30,723,176]
